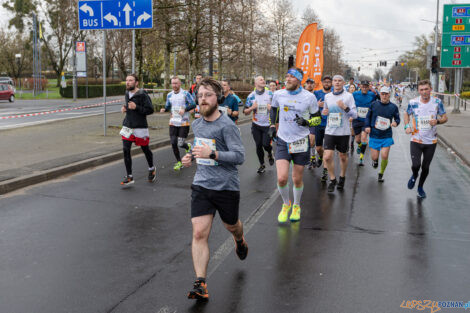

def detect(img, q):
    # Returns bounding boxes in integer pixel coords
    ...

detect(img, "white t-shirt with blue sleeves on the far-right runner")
[406,97,446,144]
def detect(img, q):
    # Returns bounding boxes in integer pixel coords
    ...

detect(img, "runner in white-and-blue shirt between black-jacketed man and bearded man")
[160,76,196,171]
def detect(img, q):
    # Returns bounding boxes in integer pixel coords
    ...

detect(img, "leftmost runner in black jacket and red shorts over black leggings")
[120,74,157,186]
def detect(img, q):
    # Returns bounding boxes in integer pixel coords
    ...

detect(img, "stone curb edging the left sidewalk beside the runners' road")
[0,119,252,195]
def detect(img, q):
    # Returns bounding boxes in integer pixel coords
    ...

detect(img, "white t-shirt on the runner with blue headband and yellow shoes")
[272,88,318,143]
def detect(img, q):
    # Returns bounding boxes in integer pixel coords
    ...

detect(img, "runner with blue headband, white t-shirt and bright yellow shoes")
[270,67,321,223]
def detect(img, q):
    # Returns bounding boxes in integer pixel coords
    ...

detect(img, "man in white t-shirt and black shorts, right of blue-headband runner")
[322,75,357,192]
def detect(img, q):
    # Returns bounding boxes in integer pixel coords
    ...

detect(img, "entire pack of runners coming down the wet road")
[120,67,447,300]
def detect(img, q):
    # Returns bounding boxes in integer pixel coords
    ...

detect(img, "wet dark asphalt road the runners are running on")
[0,109,470,313]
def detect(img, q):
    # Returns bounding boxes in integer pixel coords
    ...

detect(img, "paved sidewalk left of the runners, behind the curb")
[0,109,251,195]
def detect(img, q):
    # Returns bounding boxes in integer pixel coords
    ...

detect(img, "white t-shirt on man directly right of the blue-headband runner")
[324,91,357,136]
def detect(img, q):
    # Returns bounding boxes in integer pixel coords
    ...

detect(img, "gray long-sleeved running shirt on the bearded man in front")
[192,114,245,191]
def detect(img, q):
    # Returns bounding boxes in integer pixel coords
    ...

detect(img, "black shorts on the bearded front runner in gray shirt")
[191,185,240,225]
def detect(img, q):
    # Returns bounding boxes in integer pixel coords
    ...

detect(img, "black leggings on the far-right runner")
[410,141,437,188]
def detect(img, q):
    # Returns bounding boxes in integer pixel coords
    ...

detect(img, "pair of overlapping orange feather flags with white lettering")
[295,23,323,89]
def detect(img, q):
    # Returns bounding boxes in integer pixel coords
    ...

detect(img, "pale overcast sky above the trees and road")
[0,0,470,75]
